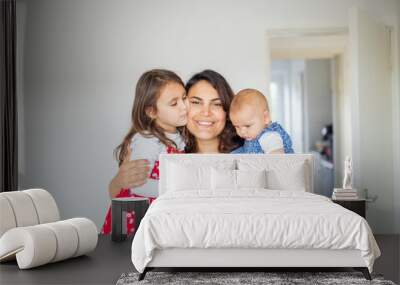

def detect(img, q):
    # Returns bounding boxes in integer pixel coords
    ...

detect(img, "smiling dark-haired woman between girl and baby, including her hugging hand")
[108,70,243,198]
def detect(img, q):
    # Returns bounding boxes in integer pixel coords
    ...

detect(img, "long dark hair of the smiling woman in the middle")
[183,69,243,153]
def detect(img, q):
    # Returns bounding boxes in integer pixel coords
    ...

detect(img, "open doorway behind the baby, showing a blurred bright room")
[269,29,351,197]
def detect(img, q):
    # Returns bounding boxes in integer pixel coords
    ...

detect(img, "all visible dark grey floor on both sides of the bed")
[0,235,400,285]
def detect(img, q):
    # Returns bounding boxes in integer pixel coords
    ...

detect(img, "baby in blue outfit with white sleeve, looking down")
[229,89,294,153]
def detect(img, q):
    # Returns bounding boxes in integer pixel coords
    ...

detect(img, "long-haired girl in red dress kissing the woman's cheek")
[102,69,187,234]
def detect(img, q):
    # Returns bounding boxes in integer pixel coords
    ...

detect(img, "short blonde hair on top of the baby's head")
[231,88,269,113]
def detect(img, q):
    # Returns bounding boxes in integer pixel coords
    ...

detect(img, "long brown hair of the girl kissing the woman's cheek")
[114,69,184,165]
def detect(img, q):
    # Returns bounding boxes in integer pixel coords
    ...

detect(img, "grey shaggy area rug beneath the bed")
[117,271,395,285]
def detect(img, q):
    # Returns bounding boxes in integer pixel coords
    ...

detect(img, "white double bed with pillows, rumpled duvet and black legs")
[132,154,380,279]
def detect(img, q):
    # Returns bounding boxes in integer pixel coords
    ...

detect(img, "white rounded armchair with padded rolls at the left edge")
[0,189,98,269]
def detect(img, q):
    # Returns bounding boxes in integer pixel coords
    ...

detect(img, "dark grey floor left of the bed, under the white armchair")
[0,235,135,285]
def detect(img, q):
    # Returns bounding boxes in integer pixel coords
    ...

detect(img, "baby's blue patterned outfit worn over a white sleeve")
[231,122,294,154]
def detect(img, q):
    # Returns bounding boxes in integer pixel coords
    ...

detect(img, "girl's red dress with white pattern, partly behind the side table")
[101,146,184,236]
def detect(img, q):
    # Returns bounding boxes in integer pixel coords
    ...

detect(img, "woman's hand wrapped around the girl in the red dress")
[108,147,149,198]
